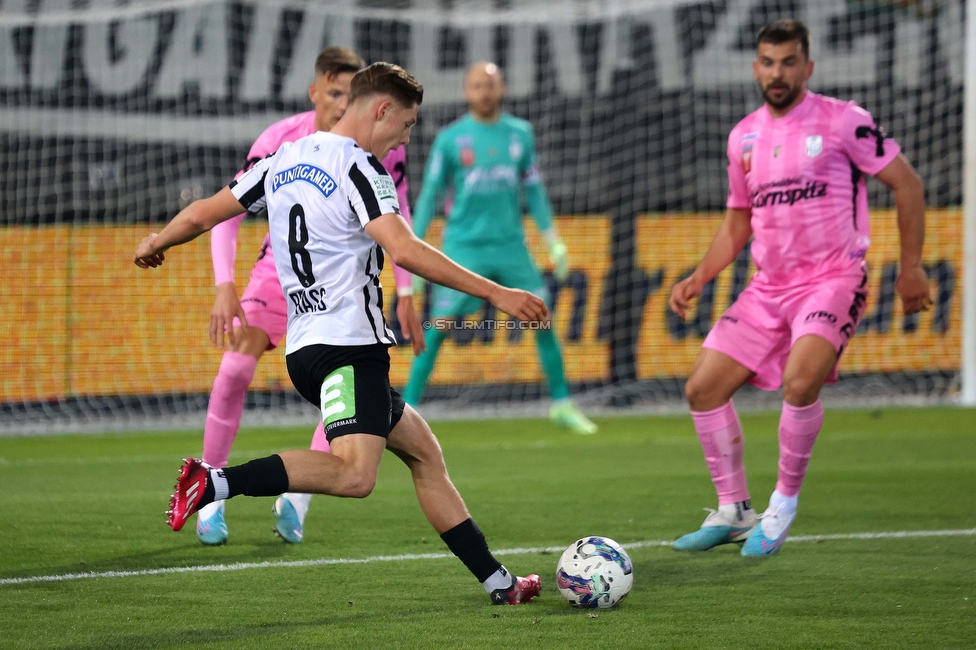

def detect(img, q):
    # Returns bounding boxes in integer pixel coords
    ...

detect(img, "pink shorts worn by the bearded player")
[702,271,867,390]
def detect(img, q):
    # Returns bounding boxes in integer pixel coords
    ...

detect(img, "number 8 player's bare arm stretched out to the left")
[134,187,244,269]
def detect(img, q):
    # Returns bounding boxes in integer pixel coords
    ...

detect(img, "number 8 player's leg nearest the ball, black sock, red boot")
[387,406,542,605]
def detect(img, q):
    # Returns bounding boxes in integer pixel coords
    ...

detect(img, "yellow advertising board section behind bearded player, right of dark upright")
[637,209,963,378]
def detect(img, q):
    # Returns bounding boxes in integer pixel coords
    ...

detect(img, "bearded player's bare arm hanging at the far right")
[876,154,932,314]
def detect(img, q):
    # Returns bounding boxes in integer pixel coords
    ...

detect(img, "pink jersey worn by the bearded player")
[727,91,901,285]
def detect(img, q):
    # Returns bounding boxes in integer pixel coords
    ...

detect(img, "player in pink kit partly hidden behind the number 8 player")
[197,47,424,545]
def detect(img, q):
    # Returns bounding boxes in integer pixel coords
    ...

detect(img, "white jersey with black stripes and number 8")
[230,132,400,354]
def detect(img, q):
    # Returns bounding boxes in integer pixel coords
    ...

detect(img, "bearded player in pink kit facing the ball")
[670,20,931,556]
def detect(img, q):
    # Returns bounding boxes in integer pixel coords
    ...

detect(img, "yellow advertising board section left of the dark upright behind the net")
[0,217,610,403]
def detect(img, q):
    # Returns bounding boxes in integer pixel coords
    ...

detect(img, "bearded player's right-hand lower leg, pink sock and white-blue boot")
[742,399,824,556]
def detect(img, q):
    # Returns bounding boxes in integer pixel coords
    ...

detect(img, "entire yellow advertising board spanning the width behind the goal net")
[0,209,962,403]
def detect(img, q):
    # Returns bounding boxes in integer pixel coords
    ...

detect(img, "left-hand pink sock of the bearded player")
[691,402,749,506]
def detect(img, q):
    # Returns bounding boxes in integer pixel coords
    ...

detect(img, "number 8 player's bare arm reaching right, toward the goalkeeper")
[366,213,549,321]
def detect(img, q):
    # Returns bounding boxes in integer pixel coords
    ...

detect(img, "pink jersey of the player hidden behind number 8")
[210,111,413,289]
